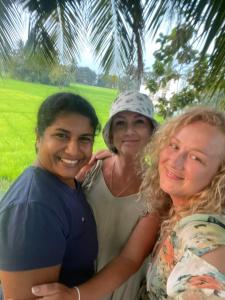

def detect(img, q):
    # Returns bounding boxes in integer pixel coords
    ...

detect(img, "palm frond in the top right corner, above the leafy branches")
[145,0,225,89]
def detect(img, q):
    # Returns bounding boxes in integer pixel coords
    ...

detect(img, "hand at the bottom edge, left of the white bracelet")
[32,283,78,300]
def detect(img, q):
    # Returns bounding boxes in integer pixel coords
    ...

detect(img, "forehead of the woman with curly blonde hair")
[172,122,225,156]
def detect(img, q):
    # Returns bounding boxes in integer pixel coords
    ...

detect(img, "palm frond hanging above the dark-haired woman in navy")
[20,0,82,61]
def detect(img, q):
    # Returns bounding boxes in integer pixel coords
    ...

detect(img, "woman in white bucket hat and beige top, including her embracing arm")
[30,92,159,300]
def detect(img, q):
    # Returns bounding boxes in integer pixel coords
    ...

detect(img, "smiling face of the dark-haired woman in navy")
[37,113,94,188]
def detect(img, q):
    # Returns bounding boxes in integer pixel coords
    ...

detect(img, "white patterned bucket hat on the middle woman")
[102,92,158,151]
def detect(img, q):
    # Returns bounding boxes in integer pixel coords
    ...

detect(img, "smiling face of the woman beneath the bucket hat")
[111,111,153,156]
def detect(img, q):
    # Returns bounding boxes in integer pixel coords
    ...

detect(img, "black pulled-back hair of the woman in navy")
[36,93,101,136]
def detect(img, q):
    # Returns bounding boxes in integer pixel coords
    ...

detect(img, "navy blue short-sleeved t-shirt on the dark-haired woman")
[0,167,98,286]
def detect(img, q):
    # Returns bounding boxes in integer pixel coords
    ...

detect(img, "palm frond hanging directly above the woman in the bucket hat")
[90,0,144,76]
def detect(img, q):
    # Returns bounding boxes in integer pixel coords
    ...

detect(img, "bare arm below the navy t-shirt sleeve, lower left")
[0,266,60,300]
